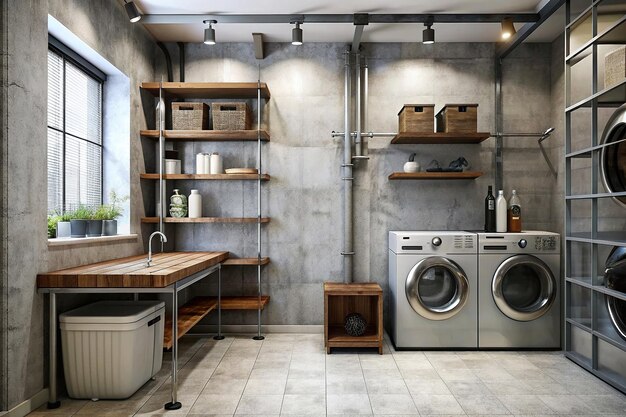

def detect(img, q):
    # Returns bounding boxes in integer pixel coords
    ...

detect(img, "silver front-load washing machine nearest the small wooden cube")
[389,231,478,349]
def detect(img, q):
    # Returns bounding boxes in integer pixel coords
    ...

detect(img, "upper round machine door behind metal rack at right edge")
[600,104,626,207]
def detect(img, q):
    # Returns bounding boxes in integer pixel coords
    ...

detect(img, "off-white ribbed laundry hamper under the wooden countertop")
[59,301,165,400]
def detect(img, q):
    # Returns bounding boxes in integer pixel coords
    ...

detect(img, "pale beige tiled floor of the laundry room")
[26,334,626,417]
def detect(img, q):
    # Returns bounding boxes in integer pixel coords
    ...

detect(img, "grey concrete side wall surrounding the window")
[0,0,160,409]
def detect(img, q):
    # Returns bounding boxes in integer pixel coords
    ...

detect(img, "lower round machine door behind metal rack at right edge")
[604,246,626,340]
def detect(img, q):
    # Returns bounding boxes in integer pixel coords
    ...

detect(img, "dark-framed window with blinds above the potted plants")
[48,37,105,212]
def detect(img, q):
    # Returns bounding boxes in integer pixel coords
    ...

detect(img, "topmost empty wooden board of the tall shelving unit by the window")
[141,82,271,100]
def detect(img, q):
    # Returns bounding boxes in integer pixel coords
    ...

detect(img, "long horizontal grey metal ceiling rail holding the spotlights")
[141,13,540,25]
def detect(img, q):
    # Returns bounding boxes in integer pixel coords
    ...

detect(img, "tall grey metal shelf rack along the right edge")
[564,0,626,393]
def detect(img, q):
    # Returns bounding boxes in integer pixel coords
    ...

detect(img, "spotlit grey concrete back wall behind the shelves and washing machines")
[156,43,556,324]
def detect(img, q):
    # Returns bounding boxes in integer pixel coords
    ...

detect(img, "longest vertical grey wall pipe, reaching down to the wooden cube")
[342,51,354,282]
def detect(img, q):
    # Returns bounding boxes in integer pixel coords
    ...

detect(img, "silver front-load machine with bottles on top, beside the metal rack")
[478,231,561,349]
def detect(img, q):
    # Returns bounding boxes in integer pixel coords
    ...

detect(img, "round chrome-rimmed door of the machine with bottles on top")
[491,255,557,321]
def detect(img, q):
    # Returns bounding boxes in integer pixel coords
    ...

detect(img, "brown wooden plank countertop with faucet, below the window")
[37,252,229,288]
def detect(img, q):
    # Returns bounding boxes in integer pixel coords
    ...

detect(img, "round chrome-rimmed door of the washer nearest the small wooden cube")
[405,256,469,320]
